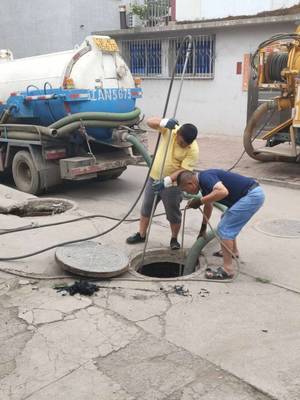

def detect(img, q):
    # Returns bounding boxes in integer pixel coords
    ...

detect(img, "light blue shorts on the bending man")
[217,186,265,240]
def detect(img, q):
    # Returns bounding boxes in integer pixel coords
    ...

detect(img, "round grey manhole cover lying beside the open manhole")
[55,241,129,278]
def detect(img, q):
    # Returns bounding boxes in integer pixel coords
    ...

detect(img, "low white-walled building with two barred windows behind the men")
[97,0,300,135]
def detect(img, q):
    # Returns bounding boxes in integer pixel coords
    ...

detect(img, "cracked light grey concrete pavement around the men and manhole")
[0,167,300,400]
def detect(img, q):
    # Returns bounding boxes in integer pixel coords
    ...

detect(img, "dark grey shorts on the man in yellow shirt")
[141,178,182,224]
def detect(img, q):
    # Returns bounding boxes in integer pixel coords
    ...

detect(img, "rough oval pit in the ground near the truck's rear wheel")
[9,199,75,217]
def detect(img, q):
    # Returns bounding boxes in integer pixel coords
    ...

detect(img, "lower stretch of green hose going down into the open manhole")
[184,203,227,275]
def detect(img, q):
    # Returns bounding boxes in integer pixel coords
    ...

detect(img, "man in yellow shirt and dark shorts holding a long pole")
[126,117,199,250]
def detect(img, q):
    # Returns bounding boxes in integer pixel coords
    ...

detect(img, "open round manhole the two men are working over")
[130,249,198,280]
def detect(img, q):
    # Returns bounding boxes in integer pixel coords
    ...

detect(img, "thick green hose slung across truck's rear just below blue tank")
[49,108,141,129]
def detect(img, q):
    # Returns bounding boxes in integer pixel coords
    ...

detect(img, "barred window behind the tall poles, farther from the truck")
[169,35,215,79]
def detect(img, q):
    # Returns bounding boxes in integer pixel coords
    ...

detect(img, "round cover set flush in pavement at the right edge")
[255,219,300,238]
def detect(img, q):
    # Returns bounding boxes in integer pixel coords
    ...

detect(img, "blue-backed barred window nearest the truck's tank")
[121,39,162,76]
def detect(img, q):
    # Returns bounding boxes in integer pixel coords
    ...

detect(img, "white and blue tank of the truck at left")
[0,35,141,141]
